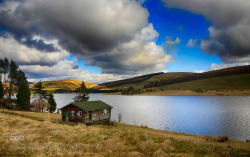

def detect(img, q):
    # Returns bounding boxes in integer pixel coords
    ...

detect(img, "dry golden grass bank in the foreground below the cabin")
[0,110,250,156]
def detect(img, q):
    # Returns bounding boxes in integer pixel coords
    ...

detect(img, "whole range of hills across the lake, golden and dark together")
[30,66,250,94]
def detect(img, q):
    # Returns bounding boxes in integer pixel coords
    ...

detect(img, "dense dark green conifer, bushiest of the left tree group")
[16,82,30,110]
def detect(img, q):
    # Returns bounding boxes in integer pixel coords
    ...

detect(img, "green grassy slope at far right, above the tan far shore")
[158,74,250,91]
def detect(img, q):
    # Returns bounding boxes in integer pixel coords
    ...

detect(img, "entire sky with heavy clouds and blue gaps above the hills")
[0,0,250,83]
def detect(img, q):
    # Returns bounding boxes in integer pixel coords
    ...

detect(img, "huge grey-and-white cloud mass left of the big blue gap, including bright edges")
[0,0,171,74]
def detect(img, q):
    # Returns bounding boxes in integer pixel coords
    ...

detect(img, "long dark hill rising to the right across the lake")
[94,66,250,93]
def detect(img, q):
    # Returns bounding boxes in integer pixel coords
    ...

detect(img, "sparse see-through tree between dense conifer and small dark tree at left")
[34,81,47,111]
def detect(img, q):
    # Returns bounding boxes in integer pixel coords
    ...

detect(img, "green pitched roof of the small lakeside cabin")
[62,101,113,111]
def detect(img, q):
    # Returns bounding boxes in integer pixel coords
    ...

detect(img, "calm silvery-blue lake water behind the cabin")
[55,94,250,141]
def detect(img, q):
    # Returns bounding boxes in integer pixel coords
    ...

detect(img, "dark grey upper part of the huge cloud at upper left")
[0,0,148,55]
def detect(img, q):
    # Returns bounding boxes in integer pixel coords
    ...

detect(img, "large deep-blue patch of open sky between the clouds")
[145,0,221,72]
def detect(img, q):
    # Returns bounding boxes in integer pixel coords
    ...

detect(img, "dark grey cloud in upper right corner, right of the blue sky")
[164,0,250,63]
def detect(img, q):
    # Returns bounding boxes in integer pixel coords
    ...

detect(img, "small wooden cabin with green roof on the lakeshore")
[60,101,113,125]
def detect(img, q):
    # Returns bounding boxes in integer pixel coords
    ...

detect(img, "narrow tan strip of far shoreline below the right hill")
[106,89,250,96]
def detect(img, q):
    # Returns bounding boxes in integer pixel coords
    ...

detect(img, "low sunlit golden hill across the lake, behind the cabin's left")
[29,80,97,91]
